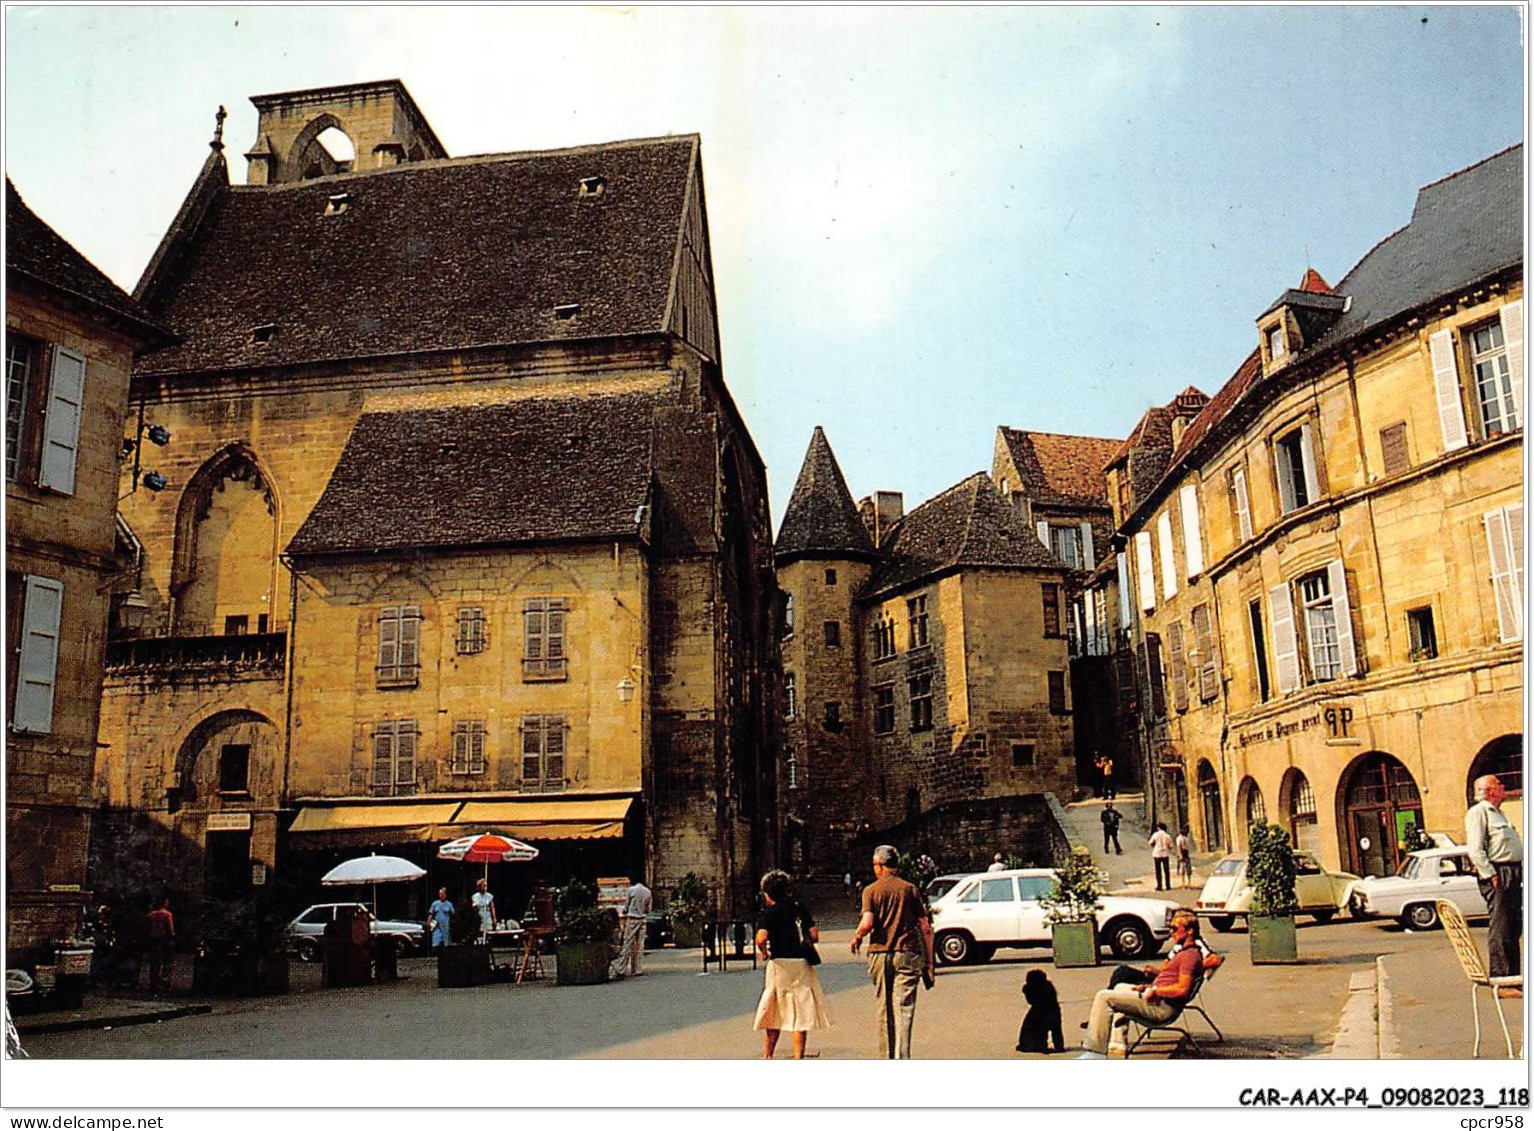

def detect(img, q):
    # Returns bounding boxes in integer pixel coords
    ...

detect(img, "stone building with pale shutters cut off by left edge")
[5,180,169,967]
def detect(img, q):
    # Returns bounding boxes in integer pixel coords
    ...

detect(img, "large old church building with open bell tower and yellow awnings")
[98,81,778,913]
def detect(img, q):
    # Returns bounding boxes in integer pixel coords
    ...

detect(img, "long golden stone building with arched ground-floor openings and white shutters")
[1094,147,1523,875]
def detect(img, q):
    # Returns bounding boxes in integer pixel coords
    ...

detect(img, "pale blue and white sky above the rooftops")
[5,5,1525,520]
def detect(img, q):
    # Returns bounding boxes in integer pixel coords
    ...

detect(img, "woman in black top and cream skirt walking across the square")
[756,869,831,1060]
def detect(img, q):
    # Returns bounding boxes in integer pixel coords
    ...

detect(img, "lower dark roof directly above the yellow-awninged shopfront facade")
[287,393,660,554]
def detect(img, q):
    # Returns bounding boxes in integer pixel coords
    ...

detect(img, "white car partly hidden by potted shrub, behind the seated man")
[928,869,1177,965]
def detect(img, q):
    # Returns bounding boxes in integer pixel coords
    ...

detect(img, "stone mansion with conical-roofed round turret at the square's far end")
[776,428,1077,876]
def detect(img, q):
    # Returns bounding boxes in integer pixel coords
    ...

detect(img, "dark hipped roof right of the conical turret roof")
[862,471,1065,598]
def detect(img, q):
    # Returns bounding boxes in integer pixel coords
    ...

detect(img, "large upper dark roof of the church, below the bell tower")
[140,135,698,373]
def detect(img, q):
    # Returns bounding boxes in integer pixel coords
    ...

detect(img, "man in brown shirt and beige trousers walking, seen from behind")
[851,844,933,1060]
